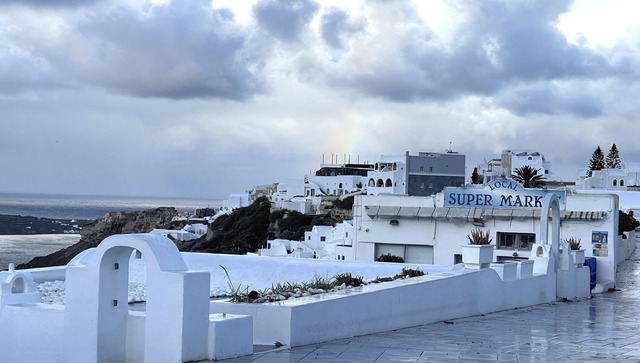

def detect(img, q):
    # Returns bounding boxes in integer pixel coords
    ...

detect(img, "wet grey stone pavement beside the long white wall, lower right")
[223,248,640,363]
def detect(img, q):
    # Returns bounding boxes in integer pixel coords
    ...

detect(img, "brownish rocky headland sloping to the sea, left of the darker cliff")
[18,207,176,268]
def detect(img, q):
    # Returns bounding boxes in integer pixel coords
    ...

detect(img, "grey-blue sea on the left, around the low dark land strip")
[0,193,222,271]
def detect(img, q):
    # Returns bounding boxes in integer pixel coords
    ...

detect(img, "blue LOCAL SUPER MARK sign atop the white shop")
[444,179,566,209]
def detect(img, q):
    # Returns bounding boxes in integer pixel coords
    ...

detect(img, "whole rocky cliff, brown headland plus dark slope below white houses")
[18,197,344,268]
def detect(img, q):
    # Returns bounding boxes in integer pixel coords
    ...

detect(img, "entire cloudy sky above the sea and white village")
[0,0,640,198]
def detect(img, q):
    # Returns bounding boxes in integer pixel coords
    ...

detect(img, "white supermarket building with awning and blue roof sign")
[353,179,635,290]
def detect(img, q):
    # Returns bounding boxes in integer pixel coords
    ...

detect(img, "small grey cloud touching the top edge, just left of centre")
[253,0,318,41]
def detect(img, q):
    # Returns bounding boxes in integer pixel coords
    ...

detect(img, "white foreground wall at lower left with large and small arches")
[0,234,253,363]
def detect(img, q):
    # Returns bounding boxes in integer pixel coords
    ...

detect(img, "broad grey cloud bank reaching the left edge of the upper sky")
[0,0,266,100]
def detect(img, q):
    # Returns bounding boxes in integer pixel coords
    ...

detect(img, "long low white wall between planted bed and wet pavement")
[210,262,556,346]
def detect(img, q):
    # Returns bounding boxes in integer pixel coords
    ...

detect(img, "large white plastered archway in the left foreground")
[64,234,209,362]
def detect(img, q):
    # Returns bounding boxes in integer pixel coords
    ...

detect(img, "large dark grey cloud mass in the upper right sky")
[328,0,638,116]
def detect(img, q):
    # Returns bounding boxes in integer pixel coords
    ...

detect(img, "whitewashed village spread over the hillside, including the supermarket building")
[172,149,640,274]
